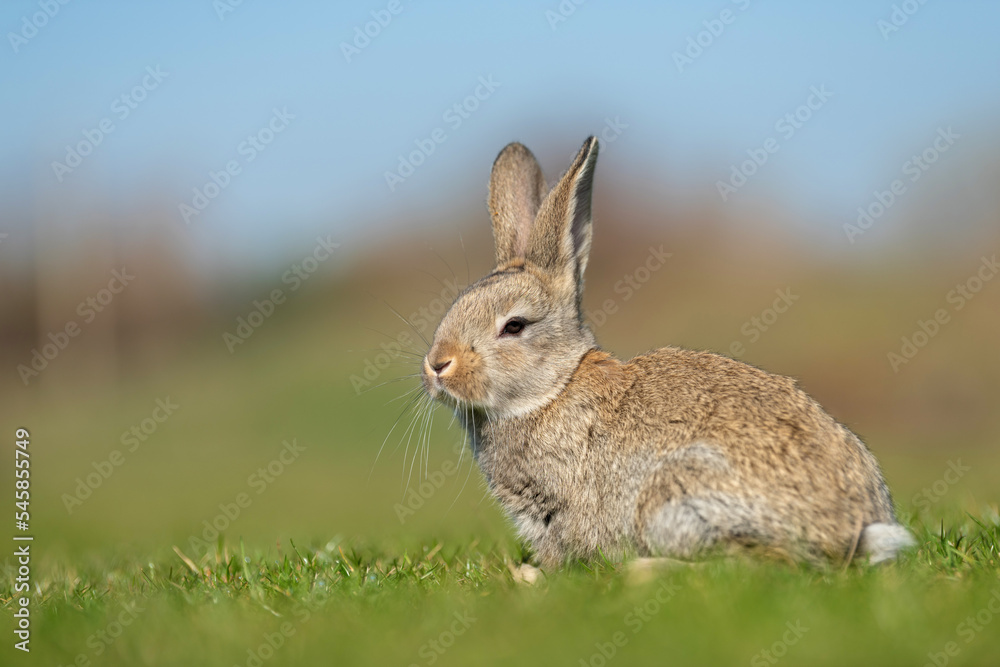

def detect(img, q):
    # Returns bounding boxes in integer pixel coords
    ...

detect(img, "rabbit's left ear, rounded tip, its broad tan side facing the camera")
[489,142,545,266]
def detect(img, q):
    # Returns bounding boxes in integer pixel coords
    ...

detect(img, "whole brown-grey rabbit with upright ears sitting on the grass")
[421,137,914,568]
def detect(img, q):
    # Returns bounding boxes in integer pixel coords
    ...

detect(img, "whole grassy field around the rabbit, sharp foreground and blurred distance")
[0,241,1000,667]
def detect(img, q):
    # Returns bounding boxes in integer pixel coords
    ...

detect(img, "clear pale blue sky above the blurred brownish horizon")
[0,0,1000,264]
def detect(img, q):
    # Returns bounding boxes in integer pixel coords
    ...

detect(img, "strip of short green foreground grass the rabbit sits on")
[7,516,1000,665]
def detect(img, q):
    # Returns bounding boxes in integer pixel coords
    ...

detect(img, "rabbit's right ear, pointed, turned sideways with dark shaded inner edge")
[525,137,598,303]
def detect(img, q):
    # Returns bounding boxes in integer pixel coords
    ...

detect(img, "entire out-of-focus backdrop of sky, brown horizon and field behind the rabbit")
[0,0,1000,558]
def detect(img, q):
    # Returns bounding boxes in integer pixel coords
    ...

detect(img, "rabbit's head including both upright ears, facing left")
[423,137,598,416]
